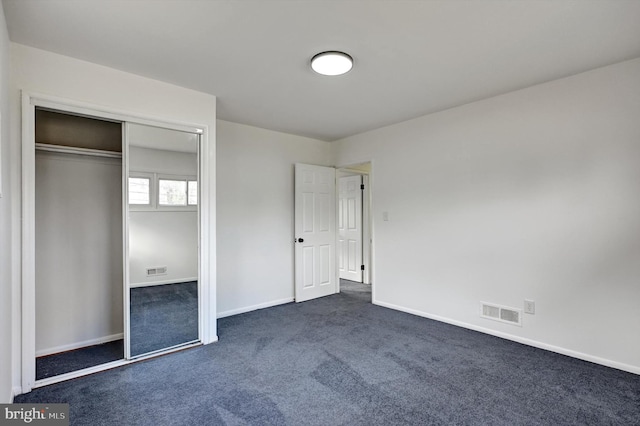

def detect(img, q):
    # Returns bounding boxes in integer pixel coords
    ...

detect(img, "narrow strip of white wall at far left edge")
[0,2,12,403]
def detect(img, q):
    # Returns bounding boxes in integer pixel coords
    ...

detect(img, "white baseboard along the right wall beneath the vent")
[373,300,640,375]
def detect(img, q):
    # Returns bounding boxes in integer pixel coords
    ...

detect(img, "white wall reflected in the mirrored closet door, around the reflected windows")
[129,146,198,286]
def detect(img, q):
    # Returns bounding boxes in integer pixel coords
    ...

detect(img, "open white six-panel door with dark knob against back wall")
[294,164,338,302]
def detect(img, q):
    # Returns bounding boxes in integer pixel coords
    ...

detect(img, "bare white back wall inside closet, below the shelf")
[35,152,123,355]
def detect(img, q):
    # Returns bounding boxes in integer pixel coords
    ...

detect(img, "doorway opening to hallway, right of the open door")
[336,162,372,300]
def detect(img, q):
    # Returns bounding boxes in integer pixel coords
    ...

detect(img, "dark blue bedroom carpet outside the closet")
[16,284,640,425]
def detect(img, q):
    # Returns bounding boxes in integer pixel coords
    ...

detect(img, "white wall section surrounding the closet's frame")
[10,43,216,387]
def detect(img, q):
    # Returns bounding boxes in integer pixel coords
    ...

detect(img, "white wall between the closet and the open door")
[217,120,330,316]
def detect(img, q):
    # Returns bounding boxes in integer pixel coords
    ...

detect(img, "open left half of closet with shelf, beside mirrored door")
[34,107,124,381]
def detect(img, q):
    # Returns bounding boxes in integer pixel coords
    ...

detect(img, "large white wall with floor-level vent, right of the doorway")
[334,59,640,373]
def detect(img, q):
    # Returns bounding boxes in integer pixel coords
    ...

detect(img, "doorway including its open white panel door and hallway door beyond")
[293,163,375,302]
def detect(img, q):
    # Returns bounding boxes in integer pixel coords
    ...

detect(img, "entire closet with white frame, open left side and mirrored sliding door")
[20,92,209,393]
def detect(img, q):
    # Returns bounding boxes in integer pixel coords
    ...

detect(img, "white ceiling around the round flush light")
[3,0,640,141]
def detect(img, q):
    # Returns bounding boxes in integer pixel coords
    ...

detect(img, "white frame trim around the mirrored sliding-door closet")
[20,91,218,393]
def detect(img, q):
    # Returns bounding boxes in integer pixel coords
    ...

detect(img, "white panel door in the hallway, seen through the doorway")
[338,175,363,282]
